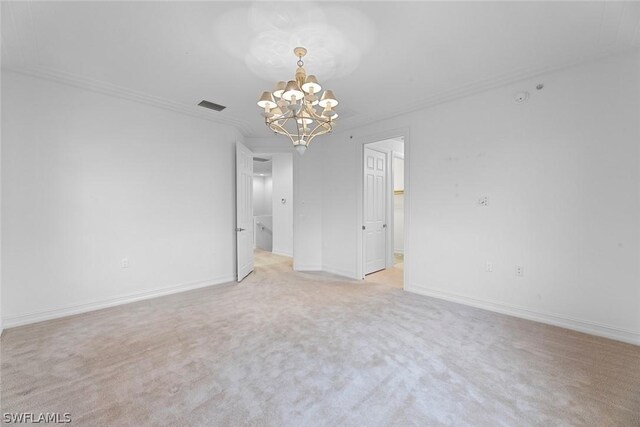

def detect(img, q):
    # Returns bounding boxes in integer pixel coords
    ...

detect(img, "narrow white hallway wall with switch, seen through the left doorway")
[271,153,294,256]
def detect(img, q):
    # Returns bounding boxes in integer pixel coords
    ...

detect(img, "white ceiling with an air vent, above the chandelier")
[2,1,640,136]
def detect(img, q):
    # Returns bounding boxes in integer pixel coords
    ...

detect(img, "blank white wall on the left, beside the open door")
[2,70,237,326]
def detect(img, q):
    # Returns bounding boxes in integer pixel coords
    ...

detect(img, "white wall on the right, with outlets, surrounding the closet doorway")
[316,52,640,343]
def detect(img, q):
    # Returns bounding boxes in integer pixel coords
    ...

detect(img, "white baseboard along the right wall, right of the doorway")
[404,285,640,345]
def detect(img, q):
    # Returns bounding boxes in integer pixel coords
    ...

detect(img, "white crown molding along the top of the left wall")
[4,66,251,136]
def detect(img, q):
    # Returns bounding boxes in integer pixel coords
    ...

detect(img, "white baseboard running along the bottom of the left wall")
[2,276,235,329]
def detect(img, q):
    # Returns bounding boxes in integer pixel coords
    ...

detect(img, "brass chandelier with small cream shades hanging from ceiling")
[258,47,338,154]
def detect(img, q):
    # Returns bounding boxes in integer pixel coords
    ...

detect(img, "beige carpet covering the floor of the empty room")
[1,252,640,426]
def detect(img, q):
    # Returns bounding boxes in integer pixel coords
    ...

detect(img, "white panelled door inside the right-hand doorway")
[363,148,387,274]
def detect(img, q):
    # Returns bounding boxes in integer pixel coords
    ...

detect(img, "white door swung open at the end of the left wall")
[236,142,253,282]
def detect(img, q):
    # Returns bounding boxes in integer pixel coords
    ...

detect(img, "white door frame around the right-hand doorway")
[356,127,412,289]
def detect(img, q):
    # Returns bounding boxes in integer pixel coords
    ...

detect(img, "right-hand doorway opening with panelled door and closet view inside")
[362,136,405,288]
